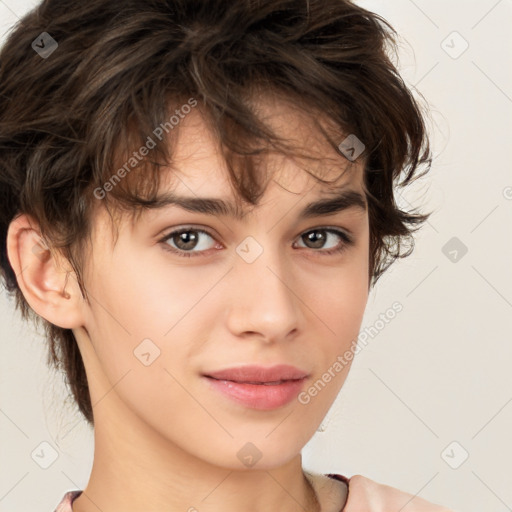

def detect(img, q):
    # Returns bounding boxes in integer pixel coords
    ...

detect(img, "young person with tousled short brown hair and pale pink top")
[0,0,448,512]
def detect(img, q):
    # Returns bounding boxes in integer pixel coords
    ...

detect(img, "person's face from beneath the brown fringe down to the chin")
[74,97,369,469]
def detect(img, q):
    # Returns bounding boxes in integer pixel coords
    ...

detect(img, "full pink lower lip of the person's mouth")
[205,377,306,410]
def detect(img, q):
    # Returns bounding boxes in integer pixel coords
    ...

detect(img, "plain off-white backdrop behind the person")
[0,0,512,512]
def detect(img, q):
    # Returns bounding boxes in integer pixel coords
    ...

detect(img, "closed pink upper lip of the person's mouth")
[204,364,308,382]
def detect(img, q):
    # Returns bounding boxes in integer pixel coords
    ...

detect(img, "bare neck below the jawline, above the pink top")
[73,400,320,512]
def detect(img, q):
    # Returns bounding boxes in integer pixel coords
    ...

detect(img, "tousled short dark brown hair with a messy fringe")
[0,0,432,425]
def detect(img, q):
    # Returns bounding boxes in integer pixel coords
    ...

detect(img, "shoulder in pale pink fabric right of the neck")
[342,475,455,512]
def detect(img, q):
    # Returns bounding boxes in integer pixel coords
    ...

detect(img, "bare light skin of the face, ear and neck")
[8,100,369,512]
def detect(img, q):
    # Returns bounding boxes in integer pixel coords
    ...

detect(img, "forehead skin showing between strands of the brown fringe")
[160,96,365,203]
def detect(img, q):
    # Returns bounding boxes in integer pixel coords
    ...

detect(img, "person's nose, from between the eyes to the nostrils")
[227,240,303,342]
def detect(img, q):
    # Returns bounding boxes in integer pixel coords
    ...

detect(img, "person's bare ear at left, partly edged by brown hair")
[7,214,85,329]
